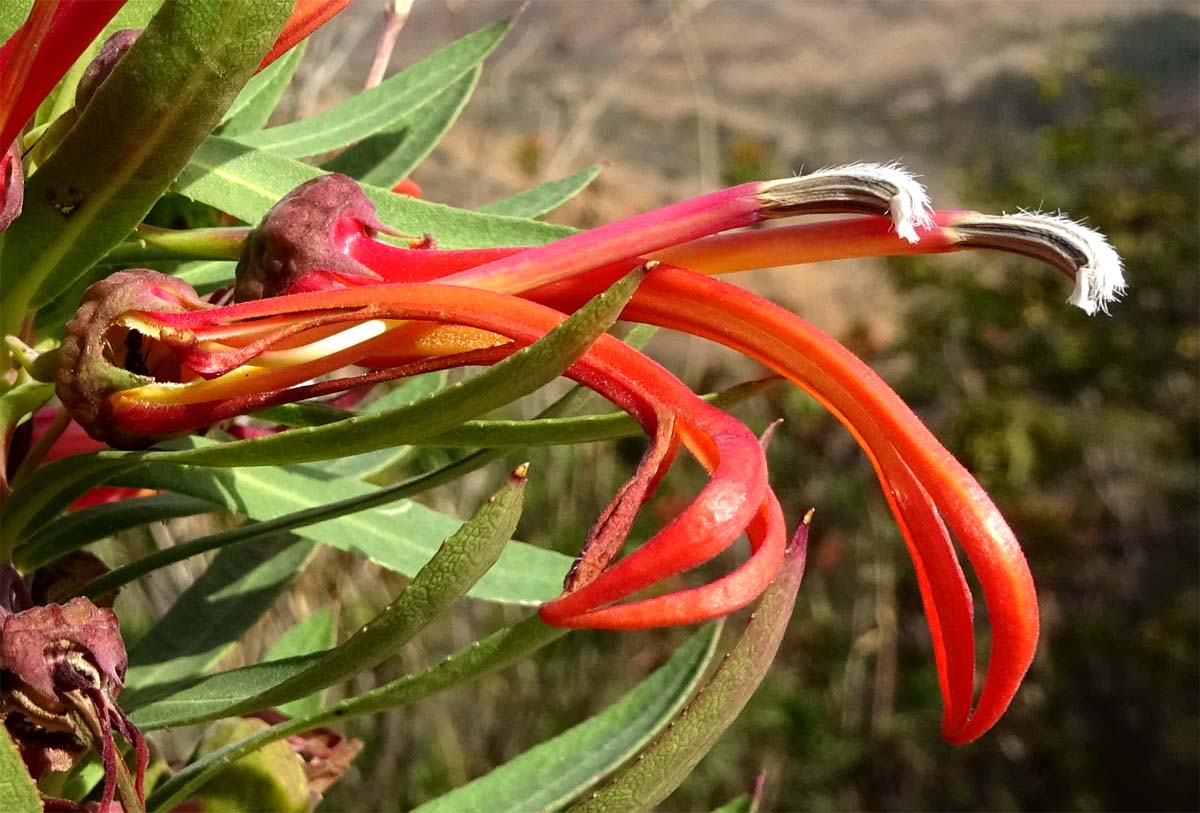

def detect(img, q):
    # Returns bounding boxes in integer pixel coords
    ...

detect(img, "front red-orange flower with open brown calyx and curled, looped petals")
[56,271,786,628]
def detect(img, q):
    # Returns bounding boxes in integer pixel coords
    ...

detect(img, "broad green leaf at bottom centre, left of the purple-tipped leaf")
[414,624,720,813]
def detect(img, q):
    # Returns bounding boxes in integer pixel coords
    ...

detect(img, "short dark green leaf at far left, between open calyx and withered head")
[13,494,212,572]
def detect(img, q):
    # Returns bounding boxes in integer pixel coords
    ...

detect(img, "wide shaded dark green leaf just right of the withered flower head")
[125,535,314,688]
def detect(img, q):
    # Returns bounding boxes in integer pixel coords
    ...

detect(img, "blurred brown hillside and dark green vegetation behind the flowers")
[121,0,1200,811]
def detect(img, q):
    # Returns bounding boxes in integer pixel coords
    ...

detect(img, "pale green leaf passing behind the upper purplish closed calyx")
[175,137,571,248]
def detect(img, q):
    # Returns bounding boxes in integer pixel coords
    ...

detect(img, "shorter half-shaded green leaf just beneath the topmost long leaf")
[322,68,482,189]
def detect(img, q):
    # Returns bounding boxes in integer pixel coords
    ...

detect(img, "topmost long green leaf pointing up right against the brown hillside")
[239,20,509,158]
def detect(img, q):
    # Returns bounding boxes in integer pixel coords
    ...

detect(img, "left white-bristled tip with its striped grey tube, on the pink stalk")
[758,163,931,243]
